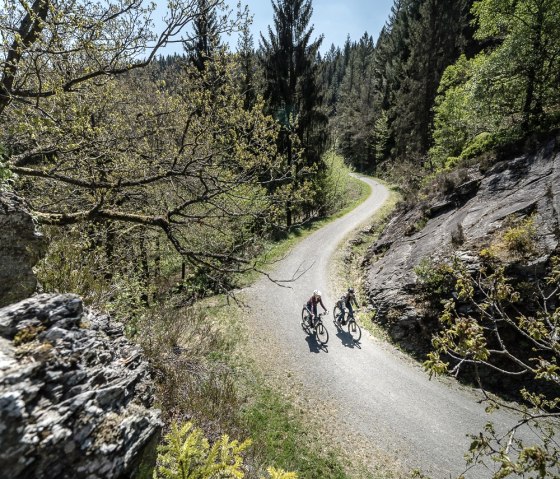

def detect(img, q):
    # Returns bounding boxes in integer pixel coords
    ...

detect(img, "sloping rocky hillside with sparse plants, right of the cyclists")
[366,136,560,352]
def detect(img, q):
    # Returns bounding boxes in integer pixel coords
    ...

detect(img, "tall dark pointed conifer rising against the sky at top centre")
[260,0,326,226]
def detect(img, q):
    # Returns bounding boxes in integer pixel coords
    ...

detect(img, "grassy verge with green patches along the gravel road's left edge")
[141,173,402,479]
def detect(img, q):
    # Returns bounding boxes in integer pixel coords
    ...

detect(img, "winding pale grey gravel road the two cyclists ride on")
[246,178,540,478]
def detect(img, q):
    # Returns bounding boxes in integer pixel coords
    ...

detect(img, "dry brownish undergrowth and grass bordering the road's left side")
[129,173,370,479]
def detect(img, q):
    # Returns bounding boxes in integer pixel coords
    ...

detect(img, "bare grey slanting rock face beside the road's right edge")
[366,135,560,344]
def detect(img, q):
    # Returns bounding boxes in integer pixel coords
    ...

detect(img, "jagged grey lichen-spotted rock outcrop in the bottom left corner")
[0,294,160,479]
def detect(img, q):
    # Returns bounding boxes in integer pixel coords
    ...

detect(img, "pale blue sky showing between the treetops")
[156,0,394,54]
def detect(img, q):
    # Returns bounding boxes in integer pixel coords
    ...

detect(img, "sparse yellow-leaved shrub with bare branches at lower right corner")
[424,258,560,479]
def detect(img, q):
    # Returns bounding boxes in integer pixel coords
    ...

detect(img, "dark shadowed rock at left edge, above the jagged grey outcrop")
[0,192,46,307]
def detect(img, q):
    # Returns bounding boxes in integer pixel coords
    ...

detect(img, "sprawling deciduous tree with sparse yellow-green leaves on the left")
[0,0,277,296]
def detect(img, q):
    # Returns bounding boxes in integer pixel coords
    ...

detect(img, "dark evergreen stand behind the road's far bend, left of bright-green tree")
[322,0,478,171]
